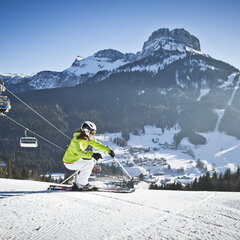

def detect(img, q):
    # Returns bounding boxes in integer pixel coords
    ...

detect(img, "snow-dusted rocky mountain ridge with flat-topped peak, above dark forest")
[0,28,225,92]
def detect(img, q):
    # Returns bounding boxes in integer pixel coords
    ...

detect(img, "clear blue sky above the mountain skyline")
[0,0,240,73]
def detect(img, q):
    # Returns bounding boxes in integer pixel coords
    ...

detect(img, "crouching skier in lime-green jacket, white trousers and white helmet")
[63,121,115,189]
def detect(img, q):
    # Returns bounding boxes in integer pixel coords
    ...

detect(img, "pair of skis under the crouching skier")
[48,185,135,193]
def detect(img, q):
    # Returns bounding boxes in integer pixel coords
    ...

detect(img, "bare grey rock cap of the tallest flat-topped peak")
[143,28,201,51]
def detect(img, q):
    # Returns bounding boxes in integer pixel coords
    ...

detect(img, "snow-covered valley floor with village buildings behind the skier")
[93,120,240,184]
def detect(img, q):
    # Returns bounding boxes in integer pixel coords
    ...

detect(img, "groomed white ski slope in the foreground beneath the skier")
[0,179,240,240]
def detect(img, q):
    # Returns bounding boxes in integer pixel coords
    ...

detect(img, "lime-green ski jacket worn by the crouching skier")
[63,132,111,163]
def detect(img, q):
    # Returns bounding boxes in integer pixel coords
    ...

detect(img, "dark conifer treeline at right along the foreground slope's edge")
[150,167,240,192]
